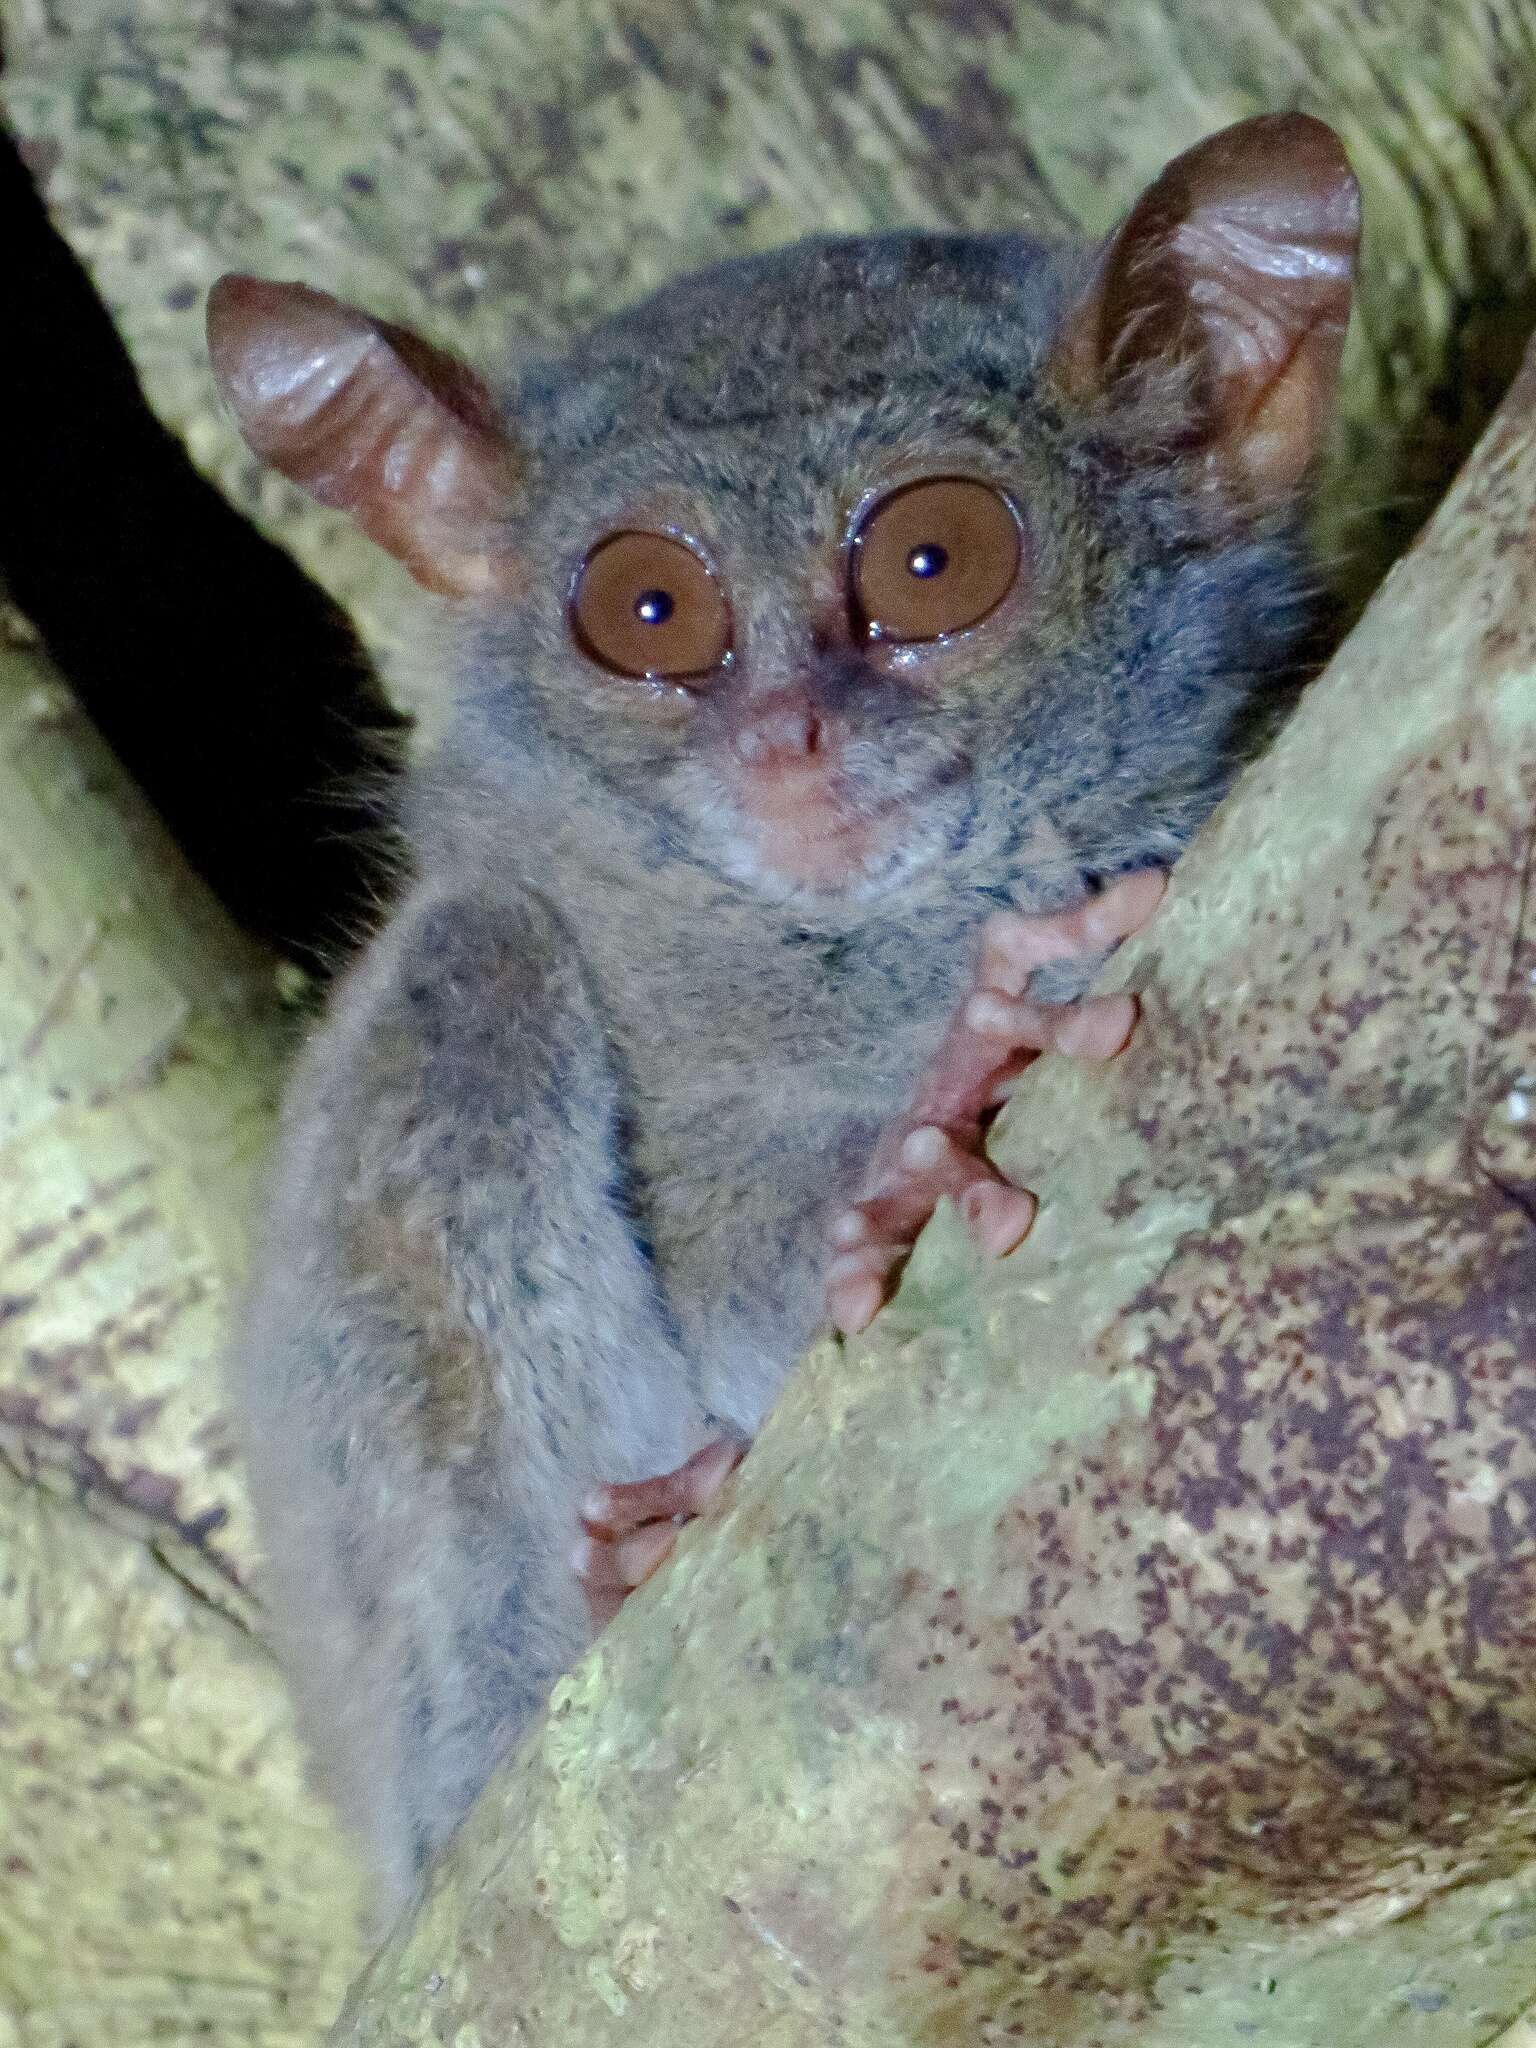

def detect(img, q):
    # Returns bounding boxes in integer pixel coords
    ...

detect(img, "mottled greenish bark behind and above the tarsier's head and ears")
[0,0,1536,667]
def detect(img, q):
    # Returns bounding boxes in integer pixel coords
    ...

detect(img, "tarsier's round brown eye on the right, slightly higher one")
[852,477,1022,641]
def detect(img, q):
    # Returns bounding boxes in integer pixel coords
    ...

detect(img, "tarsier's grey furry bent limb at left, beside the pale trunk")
[242,899,702,1905]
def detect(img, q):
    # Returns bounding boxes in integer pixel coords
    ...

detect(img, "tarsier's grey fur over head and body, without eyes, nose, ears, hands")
[242,224,1307,1903]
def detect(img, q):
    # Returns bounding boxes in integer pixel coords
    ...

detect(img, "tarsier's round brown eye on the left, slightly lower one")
[571,532,731,676]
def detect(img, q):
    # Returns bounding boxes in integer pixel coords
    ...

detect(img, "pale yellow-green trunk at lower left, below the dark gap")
[0,630,356,2048]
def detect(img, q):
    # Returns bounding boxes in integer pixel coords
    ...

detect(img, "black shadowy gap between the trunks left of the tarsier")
[0,133,403,971]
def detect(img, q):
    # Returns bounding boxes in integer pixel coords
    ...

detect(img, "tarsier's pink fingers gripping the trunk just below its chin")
[827,868,1167,1333]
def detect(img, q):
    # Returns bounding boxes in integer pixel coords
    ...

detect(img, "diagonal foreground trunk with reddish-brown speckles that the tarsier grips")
[338,344,1536,2048]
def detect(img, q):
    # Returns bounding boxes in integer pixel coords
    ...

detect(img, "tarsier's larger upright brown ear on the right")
[1053,115,1360,498]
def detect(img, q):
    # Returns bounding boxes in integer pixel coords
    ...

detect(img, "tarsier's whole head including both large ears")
[209,115,1360,901]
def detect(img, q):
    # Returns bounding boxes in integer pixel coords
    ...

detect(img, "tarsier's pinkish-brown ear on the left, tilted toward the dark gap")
[209,274,516,596]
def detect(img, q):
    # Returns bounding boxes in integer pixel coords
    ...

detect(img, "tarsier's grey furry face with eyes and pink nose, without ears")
[501,280,1083,897]
